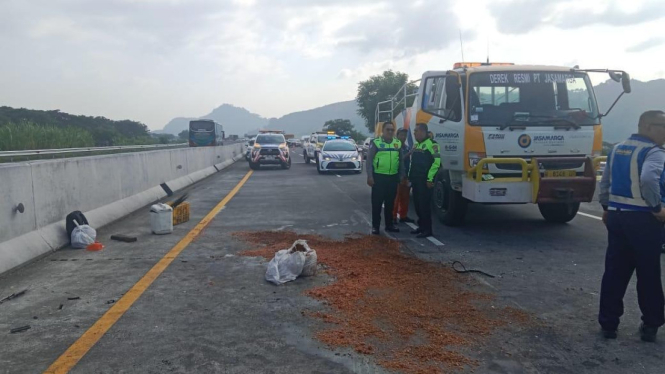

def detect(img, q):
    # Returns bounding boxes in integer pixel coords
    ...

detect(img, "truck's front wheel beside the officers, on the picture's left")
[432,171,468,226]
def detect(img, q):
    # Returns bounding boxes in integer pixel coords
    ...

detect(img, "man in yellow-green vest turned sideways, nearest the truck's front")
[409,123,441,238]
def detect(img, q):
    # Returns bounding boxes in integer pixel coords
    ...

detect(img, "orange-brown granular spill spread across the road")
[235,232,530,374]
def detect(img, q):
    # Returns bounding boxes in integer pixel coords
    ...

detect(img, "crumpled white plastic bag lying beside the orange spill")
[266,240,317,285]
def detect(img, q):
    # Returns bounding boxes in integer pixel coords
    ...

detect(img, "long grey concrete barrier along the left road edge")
[0,143,244,273]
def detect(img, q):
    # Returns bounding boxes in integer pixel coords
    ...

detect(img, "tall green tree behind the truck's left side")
[356,70,417,132]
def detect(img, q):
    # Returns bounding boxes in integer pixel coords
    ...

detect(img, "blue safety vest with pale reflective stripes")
[608,135,658,211]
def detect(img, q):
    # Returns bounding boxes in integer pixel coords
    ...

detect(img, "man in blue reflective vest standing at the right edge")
[598,110,665,342]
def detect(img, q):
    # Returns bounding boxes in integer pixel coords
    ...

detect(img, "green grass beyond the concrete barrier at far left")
[0,122,95,151]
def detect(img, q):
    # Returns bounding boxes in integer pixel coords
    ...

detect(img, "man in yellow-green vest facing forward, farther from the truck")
[366,121,406,235]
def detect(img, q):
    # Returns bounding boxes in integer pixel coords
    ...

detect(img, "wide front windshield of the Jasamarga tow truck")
[469,71,598,128]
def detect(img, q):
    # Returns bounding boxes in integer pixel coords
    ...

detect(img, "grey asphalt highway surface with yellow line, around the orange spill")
[0,152,665,373]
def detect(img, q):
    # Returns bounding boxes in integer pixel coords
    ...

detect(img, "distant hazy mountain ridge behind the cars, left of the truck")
[155,100,365,136]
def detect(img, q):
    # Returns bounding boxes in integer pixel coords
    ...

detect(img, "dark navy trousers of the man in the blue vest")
[598,211,665,330]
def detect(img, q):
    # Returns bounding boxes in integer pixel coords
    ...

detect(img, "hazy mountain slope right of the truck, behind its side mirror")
[595,79,665,143]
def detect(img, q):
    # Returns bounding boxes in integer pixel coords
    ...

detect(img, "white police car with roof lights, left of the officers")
[316,136,363,174]
